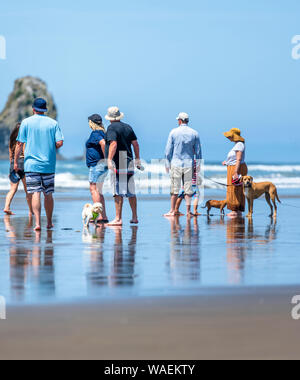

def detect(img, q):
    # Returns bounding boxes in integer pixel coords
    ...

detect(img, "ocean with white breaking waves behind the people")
[0,160,300,195]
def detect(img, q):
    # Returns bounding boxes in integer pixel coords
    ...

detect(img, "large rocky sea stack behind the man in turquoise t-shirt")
[0,77,57,159]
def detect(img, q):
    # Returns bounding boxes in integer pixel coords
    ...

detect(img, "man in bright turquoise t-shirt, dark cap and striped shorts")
[14,98,64,231]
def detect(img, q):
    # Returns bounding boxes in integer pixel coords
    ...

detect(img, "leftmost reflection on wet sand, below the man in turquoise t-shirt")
[4,216,55,301]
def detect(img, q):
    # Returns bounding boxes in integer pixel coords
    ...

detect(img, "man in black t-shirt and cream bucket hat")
[106,107,141,226]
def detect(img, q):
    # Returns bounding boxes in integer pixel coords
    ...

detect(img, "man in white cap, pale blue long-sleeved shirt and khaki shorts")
[165,112,202,217]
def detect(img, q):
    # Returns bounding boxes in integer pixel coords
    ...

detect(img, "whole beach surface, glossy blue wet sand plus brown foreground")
[0,192,300,360]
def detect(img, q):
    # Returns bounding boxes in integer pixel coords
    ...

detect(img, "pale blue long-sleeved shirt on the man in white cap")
[166,125,202,168]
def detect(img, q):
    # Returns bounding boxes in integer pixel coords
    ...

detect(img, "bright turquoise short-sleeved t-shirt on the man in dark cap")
[17,115,64,174]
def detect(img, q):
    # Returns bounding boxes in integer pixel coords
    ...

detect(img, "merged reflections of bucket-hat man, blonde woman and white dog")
[83,226,138,294]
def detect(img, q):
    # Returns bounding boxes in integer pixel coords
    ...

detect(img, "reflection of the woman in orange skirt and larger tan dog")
[227,218,277,285]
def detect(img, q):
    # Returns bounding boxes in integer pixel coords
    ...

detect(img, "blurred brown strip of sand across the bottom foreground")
[0,287,300,360]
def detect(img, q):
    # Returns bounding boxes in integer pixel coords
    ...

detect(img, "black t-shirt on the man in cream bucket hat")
[106,121,137,169]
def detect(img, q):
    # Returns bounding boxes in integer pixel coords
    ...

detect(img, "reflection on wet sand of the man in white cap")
[169,217,201,285]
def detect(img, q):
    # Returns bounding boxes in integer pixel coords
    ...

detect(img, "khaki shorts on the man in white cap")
[171,167,194,196]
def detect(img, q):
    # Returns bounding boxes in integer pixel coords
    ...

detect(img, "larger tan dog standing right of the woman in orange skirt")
[243,176,281,218]
